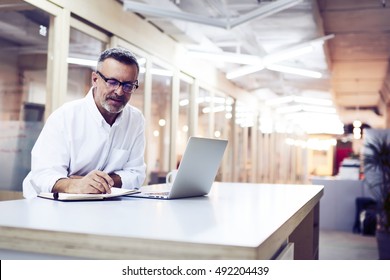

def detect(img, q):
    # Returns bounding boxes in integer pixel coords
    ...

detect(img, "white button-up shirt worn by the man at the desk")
[23,89,146,198]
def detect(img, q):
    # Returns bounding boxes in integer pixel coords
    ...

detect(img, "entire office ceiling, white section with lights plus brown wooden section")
[121,0,390,131]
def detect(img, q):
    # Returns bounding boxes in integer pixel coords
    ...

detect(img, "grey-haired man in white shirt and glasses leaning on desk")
[23,48,146,198]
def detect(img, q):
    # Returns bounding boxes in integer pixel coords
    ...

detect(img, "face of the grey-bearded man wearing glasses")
[92,58,138,120]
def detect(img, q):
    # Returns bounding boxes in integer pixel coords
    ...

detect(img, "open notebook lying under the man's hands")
[38,188,139,201]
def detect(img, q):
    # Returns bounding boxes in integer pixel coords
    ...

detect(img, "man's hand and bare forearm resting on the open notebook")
[52,170,114,193]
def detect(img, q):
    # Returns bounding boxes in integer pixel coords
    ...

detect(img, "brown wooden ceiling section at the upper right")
[318,0,390,127]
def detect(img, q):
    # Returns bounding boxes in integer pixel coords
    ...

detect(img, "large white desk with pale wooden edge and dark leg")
[0,183,323,259]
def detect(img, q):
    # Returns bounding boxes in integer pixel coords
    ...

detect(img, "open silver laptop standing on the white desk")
[131,137,228,199]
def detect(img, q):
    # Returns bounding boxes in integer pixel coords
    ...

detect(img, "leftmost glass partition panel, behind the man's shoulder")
[0,1,51,191]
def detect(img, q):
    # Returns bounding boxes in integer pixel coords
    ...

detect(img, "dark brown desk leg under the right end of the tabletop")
[289,204,319,260]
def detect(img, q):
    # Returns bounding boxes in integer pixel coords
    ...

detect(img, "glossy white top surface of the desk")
[0,183,323,247]
